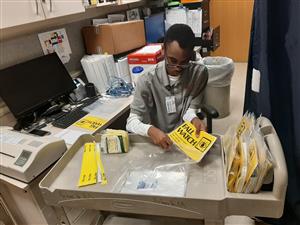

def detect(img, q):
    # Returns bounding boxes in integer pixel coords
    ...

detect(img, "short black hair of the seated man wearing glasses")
[164,23,195,50]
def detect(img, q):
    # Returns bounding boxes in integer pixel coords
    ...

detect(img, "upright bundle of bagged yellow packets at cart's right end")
[222,113,273,193]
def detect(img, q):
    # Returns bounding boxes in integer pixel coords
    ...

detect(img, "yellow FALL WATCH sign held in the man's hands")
[169,122,217,162]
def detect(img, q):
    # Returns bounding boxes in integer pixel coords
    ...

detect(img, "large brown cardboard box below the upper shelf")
[82,20,146,54]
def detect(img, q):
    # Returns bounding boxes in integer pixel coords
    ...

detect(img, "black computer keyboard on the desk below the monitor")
[52,108,88,129]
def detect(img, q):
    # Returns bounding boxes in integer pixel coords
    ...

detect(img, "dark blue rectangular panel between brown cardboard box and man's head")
[144,12,165,43]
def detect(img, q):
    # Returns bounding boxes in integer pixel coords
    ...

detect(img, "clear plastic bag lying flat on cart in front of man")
[114,146,195,197]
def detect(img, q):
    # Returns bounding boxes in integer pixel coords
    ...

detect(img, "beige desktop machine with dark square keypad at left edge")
[0,126,67,183]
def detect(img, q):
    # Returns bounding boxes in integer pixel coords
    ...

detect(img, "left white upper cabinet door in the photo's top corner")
[0,0,45,28]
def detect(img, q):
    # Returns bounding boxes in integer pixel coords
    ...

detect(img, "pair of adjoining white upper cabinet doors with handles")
[0,0,85,28]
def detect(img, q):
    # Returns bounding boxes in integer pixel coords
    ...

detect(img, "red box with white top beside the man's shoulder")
[127,44,162,64]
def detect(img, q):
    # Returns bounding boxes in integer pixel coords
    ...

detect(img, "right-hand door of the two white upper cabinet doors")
[40,0,85,19]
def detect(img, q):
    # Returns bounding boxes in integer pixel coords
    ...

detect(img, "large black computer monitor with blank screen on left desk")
[0,53,76,119]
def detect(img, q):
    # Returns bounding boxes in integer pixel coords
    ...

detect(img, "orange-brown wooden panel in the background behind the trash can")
[210,0,254,62]
